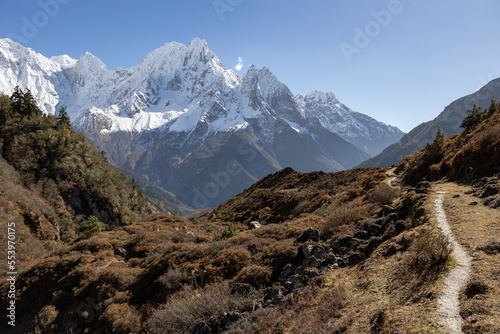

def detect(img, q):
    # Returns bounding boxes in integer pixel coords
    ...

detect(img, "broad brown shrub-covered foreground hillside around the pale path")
[0,92,500,334]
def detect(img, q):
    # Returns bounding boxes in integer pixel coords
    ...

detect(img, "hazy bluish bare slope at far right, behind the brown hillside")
[360,78,500,167]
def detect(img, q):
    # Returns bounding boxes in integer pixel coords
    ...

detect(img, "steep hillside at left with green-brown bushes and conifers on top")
[0,90,150,275]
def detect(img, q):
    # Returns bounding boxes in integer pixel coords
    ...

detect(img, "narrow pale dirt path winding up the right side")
[434,191,471,334]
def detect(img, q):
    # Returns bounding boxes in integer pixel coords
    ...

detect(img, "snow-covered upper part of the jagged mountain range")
[0,38,399,157]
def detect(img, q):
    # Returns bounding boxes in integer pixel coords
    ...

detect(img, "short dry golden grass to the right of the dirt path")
[439,183,500,333]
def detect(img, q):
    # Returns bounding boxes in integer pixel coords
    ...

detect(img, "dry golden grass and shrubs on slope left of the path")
[226,189,449,334]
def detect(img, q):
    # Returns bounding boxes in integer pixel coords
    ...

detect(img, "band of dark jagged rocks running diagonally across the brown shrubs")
[270,187,427,306]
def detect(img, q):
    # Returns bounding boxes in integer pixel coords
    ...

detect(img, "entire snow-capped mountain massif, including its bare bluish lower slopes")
[0,39,403,207]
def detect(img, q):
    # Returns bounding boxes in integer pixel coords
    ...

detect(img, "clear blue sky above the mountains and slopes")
[0,0,500,131]
